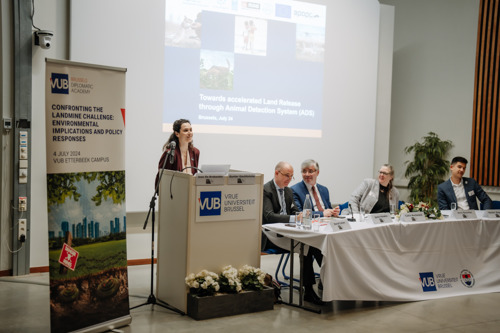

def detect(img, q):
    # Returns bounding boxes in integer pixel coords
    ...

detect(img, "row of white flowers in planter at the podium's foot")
[185,265,266,296]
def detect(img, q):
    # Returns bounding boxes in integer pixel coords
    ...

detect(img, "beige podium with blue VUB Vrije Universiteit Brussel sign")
[156,170,263,312]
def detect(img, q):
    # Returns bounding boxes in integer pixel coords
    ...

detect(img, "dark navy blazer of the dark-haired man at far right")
[438,177,492,210]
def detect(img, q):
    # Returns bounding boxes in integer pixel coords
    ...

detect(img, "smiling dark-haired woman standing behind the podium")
[155,119,200,188]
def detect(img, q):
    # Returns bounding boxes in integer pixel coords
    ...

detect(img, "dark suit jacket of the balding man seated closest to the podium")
[261,180,300,251]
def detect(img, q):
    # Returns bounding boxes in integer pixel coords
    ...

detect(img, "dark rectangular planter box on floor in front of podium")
[187,287,274,320]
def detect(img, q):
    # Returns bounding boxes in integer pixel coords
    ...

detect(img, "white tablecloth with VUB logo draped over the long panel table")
[262,218,500,301]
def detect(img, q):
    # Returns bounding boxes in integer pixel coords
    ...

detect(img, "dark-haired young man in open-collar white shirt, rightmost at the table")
[438,156,492,210]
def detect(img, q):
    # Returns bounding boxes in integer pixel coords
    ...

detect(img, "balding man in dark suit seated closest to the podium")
[262,162,324,305]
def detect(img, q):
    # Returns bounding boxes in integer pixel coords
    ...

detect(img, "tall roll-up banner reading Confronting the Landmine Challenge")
[45,59,131,332]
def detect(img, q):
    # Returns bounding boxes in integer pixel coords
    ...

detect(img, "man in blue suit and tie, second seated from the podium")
[292,160,340,217]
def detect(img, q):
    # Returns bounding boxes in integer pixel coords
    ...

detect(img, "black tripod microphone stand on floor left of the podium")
[130,146,185,315]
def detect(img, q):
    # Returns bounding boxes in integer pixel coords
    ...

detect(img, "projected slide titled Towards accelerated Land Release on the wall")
[163,0,326,137]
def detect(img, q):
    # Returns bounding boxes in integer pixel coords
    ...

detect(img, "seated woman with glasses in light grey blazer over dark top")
[349,164,399,213]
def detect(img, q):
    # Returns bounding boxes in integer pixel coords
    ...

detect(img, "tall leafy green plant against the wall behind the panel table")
[404,132,453,205]
